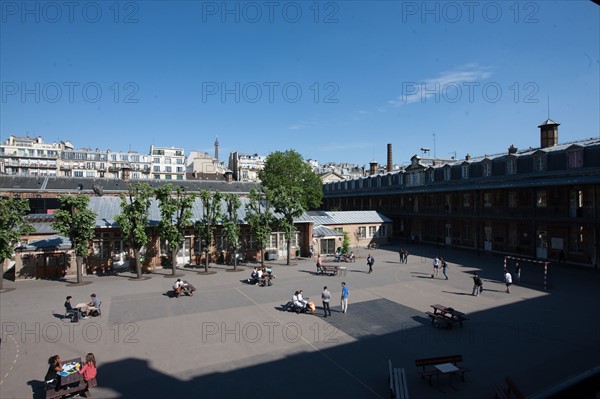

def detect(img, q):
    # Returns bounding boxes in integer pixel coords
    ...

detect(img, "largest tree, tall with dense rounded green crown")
[258,150,323,265]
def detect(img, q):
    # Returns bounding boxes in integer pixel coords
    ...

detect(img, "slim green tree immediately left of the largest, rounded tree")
[246,188,274,266]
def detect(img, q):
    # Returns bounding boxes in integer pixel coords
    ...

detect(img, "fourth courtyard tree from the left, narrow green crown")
[156,184,196,276]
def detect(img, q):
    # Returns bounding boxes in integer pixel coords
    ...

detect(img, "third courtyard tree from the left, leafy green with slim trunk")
[115,183,154,278]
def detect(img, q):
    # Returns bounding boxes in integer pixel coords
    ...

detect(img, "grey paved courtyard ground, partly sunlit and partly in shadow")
[0,246,600,399]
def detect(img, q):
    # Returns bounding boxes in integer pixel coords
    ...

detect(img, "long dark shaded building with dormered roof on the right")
[324,119,600,265]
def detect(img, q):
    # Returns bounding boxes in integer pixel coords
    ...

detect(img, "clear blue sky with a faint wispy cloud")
[0,0,600,165]
